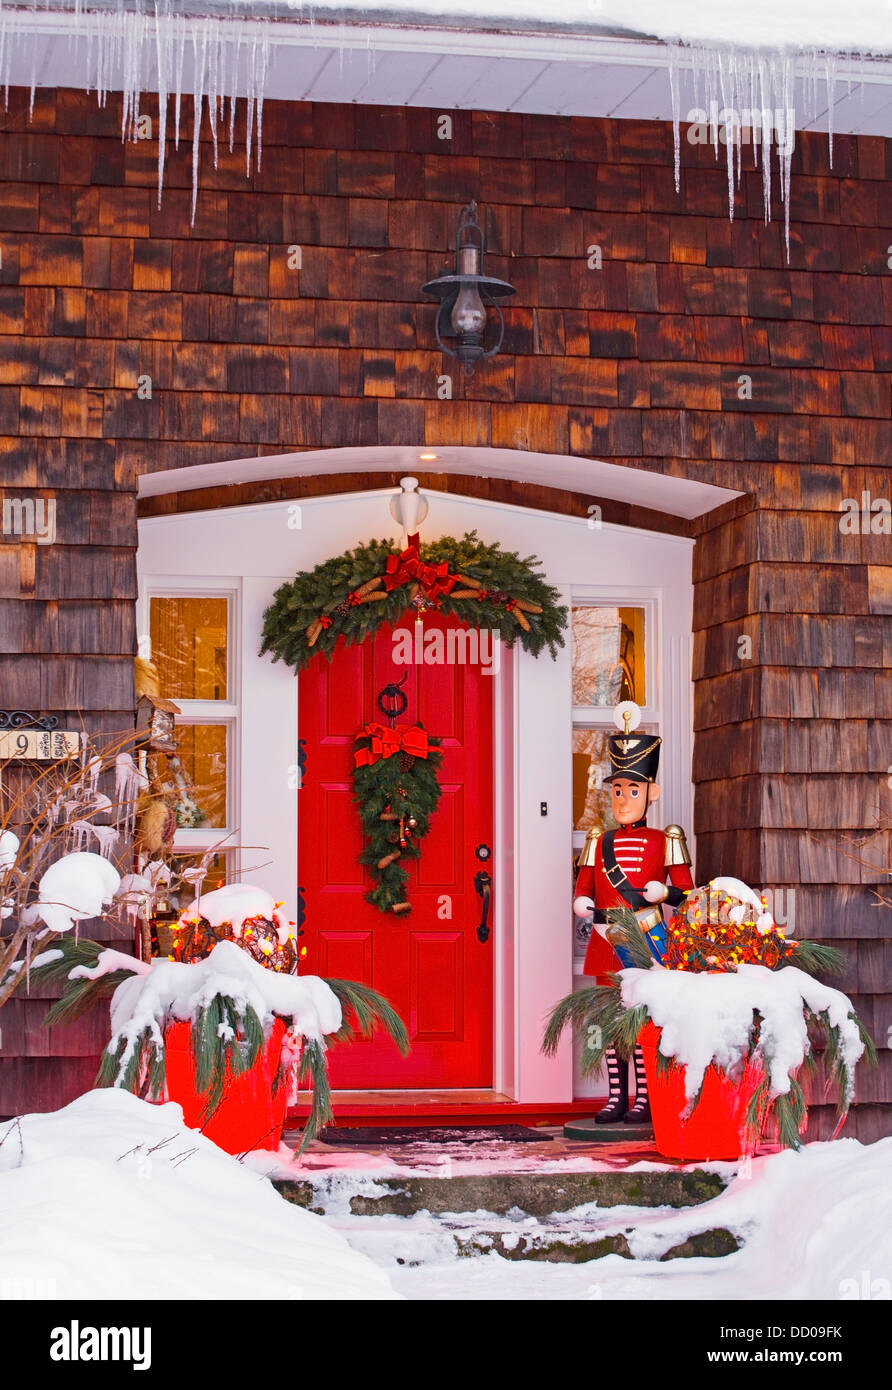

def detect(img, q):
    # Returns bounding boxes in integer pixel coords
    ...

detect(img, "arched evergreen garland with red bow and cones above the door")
[260,531,567,670]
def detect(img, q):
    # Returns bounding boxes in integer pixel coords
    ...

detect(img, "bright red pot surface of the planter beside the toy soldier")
[638,1023,764,1161]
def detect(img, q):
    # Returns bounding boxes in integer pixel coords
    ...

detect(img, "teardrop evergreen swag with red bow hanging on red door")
[353,723,443,916]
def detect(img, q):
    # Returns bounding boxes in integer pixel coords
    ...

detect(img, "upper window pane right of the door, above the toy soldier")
[572,605,647,708]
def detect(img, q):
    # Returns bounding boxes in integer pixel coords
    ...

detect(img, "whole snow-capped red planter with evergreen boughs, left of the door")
[21,922,408,1154]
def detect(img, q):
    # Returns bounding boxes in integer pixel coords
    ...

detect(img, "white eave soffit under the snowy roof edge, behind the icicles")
[6,8,892,135]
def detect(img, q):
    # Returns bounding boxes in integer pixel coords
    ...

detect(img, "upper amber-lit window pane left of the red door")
[149,598,229,699]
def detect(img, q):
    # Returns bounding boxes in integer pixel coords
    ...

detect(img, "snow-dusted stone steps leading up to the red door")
[274,1129,738,1269]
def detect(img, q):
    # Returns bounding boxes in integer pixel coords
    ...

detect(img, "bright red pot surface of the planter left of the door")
[164,1019,288,1154]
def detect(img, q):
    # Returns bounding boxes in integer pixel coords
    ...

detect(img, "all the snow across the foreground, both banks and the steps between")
[0,1090,892,1301]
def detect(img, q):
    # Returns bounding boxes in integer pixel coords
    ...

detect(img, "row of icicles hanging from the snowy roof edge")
[0,0,878,257]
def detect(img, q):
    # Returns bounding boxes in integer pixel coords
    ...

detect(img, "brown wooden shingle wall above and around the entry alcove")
[0,84,892,1137]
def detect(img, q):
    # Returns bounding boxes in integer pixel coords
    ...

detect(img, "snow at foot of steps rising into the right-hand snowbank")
[380,1140,892,1301]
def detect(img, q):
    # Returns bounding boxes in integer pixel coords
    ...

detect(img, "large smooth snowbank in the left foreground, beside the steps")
[0,1090,397,1304]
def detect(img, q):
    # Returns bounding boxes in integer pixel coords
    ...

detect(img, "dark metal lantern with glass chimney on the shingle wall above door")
[424,203,514,377]
